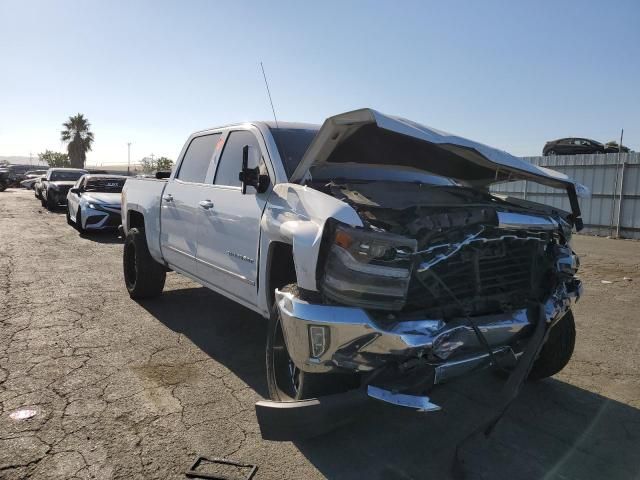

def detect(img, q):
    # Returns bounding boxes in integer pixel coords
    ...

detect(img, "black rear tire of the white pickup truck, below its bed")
[122,228,167,300]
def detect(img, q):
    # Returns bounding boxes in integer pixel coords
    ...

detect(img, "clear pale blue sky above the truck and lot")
[0,0,640,164]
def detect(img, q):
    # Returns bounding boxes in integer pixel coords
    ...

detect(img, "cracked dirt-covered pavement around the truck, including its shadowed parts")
[0,189,640,479]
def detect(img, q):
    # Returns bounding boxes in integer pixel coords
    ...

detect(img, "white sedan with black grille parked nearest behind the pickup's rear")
[67,174,128,232]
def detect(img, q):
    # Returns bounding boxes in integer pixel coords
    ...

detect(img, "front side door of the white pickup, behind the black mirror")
[192,129,269,305]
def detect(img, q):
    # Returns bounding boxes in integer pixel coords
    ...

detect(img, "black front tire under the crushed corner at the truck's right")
[529,310,576,381]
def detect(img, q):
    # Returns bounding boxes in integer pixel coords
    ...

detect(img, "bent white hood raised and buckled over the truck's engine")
[290,108,575,189]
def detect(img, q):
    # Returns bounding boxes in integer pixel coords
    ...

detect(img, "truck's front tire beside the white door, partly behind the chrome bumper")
[266,284,359,402]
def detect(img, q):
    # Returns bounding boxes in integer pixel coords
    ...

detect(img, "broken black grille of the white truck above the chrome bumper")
[406,234,549,318]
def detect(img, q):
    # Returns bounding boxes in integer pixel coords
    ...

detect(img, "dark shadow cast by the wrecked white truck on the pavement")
[142,288,640,479]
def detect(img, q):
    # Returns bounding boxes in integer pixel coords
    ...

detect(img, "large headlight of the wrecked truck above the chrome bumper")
[321,225,417,310]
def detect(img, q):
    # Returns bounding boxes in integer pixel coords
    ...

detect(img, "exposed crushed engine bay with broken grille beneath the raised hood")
[313,180,571,319]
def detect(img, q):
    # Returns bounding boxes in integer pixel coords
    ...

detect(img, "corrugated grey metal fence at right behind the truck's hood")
[492,152,640,239]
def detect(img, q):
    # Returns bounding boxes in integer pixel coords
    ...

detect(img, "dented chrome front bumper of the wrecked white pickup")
[276,279,582,383]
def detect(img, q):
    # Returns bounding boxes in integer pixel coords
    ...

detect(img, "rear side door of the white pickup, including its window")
[160,133,221,275]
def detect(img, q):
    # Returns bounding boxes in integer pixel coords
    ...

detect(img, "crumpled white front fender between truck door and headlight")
[261,183,363,290]
